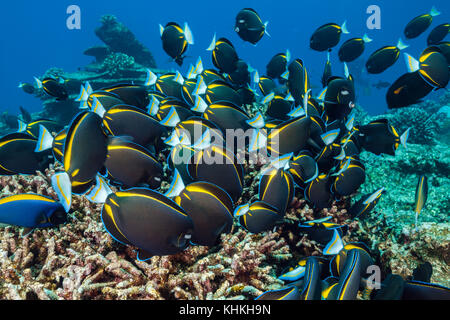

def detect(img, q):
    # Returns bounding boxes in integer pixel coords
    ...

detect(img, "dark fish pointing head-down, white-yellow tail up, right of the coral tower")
[159,22,194,66]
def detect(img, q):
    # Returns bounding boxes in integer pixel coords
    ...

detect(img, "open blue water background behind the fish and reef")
[0,0,450,114]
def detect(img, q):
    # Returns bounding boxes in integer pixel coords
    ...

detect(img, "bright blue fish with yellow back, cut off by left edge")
[0,194,67,228]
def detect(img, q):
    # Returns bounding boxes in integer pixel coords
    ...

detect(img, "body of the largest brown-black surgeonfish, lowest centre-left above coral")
[101,188,193,260]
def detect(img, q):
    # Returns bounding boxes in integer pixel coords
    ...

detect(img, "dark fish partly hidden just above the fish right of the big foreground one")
[188,145,244,201]
